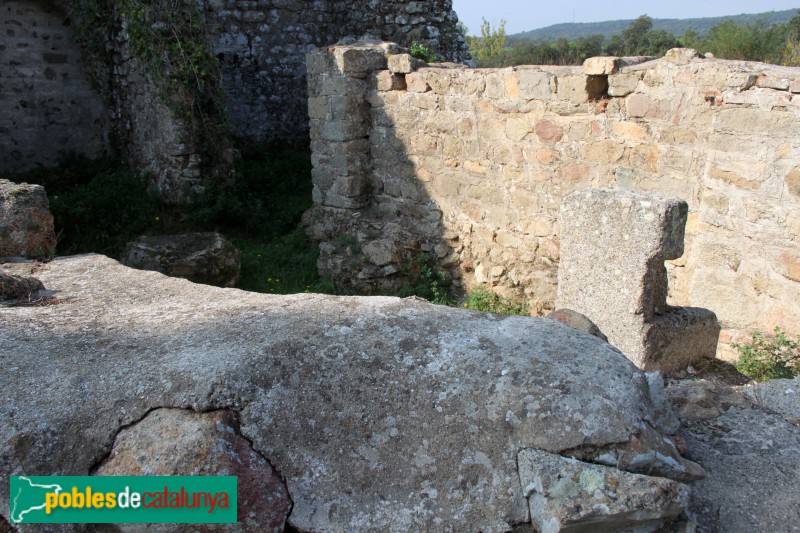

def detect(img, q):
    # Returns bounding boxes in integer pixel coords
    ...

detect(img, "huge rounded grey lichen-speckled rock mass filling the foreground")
[0,255,684,531]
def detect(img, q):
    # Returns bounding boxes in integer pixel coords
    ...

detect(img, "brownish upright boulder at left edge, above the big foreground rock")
[0,179,56,258]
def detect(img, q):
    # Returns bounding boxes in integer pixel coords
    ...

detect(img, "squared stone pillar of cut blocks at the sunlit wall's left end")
[306,43,386,209]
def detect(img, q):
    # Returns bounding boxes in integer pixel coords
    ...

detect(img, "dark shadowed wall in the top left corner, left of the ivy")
[0,0,108,172]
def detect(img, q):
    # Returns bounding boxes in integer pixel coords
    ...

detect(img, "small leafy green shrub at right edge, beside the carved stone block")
[731,328,800,381]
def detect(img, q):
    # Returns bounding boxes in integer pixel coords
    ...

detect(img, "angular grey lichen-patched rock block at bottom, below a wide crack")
[517,449,689,533]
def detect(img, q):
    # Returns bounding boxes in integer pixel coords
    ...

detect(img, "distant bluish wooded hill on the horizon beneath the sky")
[508,7,800,44]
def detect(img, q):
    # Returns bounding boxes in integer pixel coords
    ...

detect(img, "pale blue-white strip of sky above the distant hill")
[453,0,800,35]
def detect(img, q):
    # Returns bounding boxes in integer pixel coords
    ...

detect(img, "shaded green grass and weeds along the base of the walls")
[0,146,528,314]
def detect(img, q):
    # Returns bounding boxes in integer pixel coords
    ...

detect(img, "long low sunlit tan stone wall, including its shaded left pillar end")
[306,45,800,352]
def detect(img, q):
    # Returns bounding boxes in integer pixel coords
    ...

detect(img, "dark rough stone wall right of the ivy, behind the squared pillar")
[205,0,466,143]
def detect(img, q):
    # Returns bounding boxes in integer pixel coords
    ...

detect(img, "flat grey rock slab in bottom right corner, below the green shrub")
[667,374,800,533]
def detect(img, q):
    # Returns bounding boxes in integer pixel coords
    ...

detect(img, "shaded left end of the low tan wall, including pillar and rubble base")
[304,42,464,299]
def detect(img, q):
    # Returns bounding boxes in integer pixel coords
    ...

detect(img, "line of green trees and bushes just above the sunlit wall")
[462,11,800,67]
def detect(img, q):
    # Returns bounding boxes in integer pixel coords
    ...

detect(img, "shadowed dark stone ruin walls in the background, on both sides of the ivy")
[0,0,466,179]
